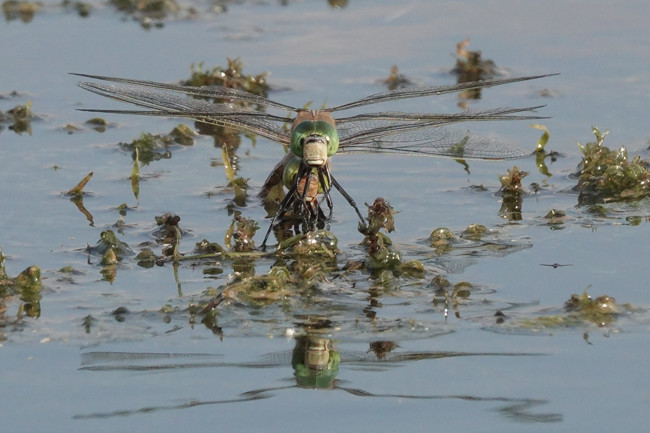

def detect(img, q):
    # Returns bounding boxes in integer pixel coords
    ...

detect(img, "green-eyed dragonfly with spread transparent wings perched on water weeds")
[73,74,556,249]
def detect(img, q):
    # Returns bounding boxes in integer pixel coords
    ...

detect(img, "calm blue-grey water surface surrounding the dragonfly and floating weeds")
[0,0,650,432]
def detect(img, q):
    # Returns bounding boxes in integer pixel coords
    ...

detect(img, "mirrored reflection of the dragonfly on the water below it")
[75,332,562,423]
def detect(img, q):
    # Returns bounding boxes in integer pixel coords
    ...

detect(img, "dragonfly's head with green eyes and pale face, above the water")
[291,120,339,167]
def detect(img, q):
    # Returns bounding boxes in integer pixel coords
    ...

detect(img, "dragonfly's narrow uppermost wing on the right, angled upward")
[328,74,558,112]
